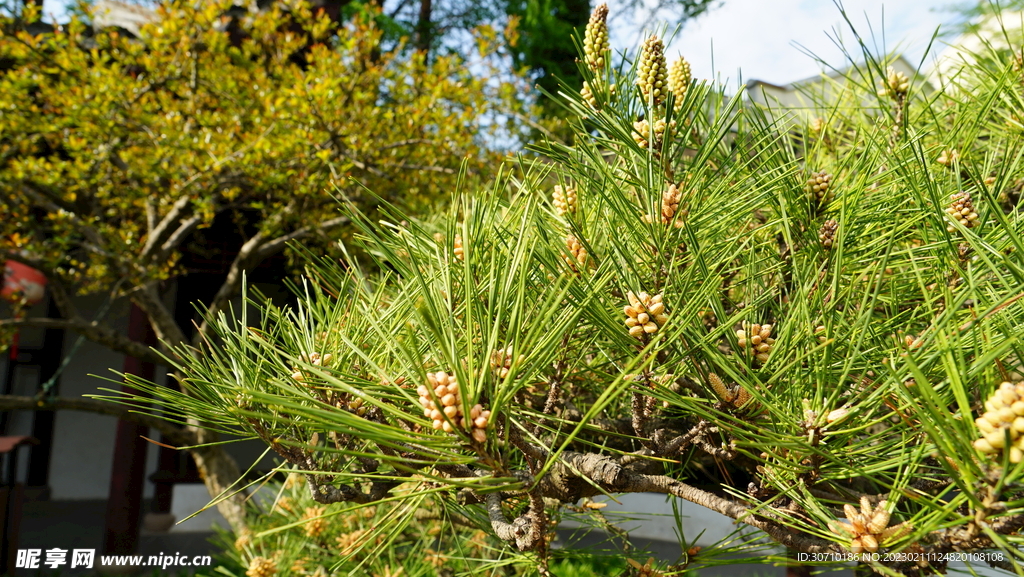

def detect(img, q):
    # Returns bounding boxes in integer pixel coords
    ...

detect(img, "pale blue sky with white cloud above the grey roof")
[608,0,961,88]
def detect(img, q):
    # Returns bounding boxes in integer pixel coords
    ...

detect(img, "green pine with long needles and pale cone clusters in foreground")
[105,5,1024,575]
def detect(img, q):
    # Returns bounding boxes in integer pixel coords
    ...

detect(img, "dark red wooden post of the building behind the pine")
[103,304,156,554]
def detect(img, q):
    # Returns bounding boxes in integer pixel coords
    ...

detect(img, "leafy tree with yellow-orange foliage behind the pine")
[0,3,528,532]
